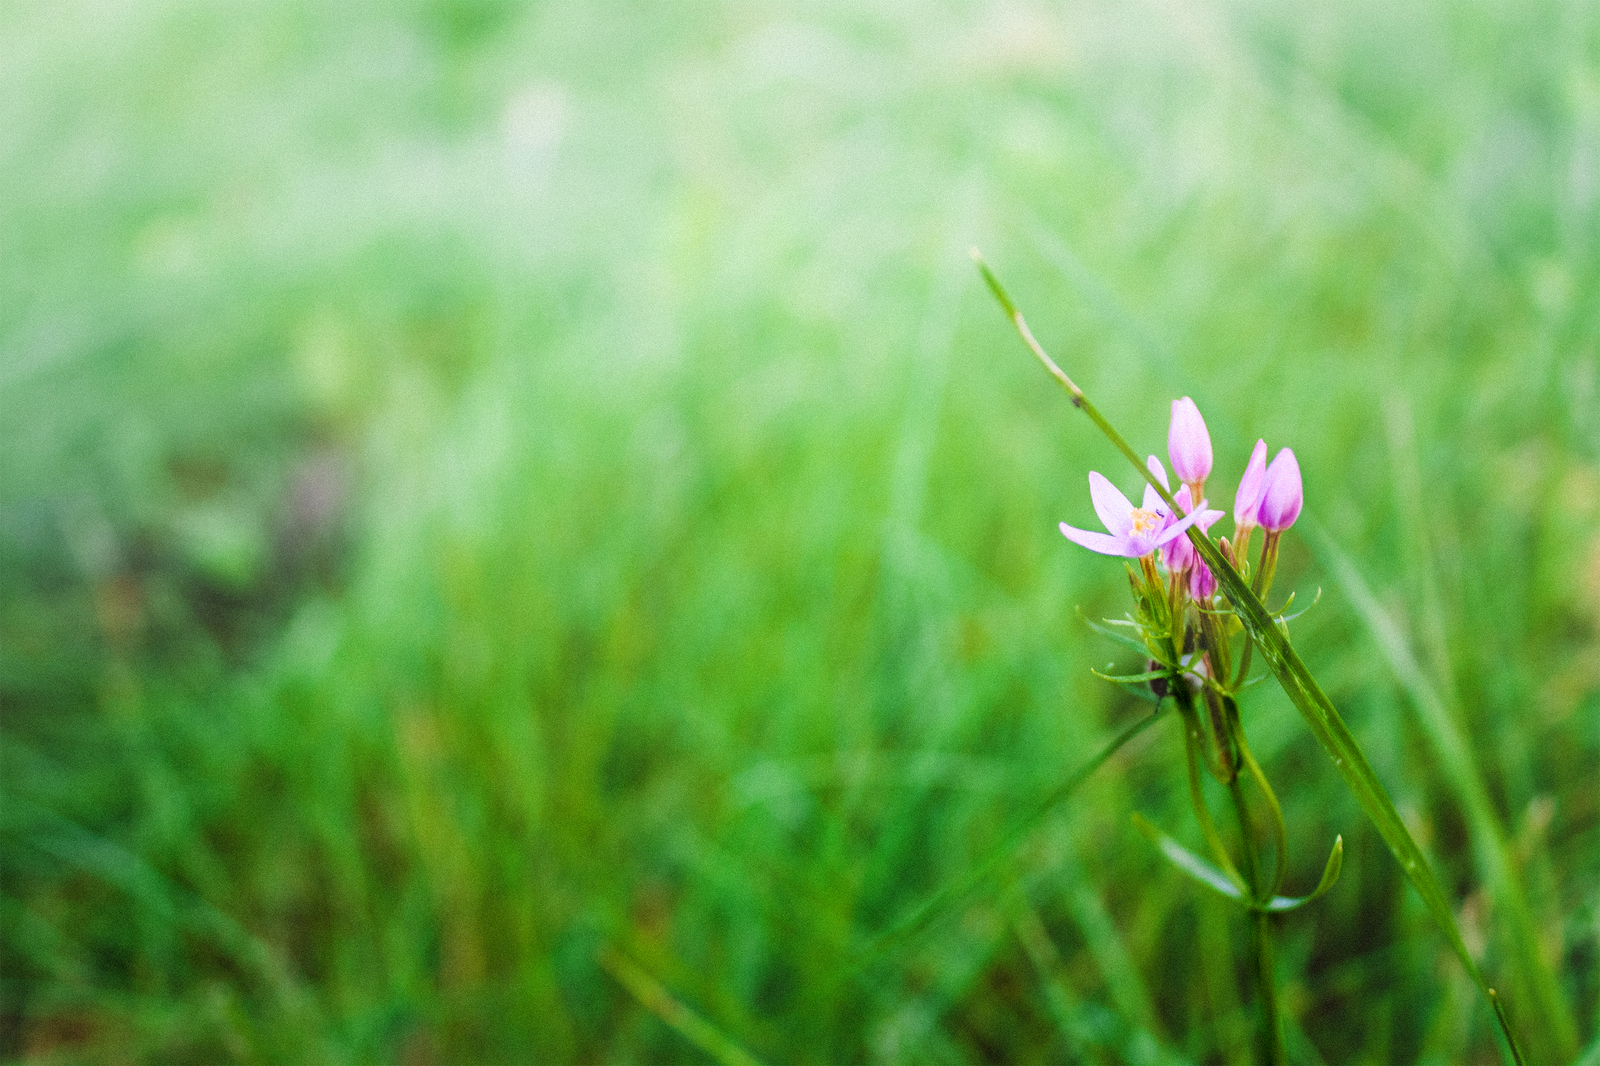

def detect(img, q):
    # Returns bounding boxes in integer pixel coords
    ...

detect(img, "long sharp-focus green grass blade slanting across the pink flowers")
[971,248,1523,1066]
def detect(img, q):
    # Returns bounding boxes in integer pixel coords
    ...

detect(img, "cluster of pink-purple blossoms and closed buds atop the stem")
[1061,397,1304,603]
